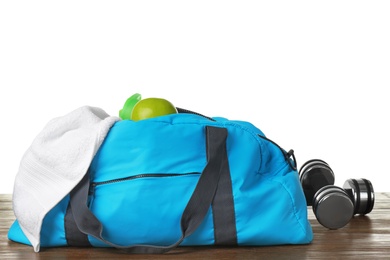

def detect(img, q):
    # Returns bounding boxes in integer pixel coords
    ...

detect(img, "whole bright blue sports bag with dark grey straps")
[9,109,313,253]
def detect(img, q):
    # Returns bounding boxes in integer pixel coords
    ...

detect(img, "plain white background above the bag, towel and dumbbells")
[0,0,390,193]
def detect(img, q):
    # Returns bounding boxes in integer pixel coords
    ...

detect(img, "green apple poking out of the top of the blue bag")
[131,98,177,121]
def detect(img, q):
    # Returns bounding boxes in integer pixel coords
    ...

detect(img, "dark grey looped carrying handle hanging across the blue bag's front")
[70,126,228,254]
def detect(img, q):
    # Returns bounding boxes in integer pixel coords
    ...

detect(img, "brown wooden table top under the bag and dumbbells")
[0,193,390,260]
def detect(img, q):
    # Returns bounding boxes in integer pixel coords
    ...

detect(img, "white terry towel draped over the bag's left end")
[13,106,119,252]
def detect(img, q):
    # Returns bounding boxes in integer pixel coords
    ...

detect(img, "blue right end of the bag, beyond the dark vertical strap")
[224,126,313,245]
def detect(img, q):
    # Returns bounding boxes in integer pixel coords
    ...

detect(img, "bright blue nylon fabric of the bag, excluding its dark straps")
[9,113,313,252]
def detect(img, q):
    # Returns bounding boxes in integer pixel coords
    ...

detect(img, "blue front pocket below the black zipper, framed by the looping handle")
[89,173,213,246]
